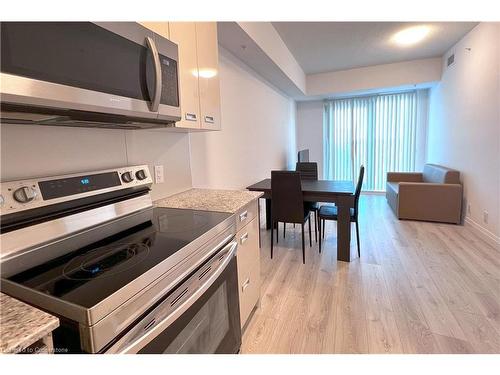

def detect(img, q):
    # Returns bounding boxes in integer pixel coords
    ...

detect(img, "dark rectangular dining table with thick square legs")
[247,178,354,262]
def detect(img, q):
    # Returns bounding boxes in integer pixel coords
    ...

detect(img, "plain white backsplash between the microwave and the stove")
[0,124,191,203]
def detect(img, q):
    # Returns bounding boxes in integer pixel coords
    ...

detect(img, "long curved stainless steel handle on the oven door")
[105,241,238,354]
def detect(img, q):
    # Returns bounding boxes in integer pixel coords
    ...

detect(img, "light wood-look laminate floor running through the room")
[241,195,500,353]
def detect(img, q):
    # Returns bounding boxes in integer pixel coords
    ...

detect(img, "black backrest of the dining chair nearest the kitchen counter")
[271,171,304,223]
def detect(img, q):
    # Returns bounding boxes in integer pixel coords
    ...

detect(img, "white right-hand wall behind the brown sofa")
[427,23,500,243]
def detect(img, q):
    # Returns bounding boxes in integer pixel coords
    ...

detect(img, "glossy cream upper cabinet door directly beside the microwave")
[169,22,201,129]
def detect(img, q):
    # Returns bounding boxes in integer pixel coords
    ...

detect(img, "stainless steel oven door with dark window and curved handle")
[104,242,241,354]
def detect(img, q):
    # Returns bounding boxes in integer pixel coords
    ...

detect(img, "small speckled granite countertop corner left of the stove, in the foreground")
[0,292,59,353]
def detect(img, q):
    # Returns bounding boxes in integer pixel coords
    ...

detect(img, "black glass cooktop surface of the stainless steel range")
[8,208,231,308]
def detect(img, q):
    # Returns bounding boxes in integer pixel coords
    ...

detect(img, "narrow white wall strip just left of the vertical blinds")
[297,100,324,178]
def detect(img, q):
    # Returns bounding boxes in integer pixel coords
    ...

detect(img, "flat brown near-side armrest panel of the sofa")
[398,182,462,224]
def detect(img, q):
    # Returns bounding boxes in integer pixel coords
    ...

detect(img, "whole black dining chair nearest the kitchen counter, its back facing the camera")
[271,171,312,264]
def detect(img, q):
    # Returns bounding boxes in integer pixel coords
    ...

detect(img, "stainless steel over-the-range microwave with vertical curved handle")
[0,22,181,128]
